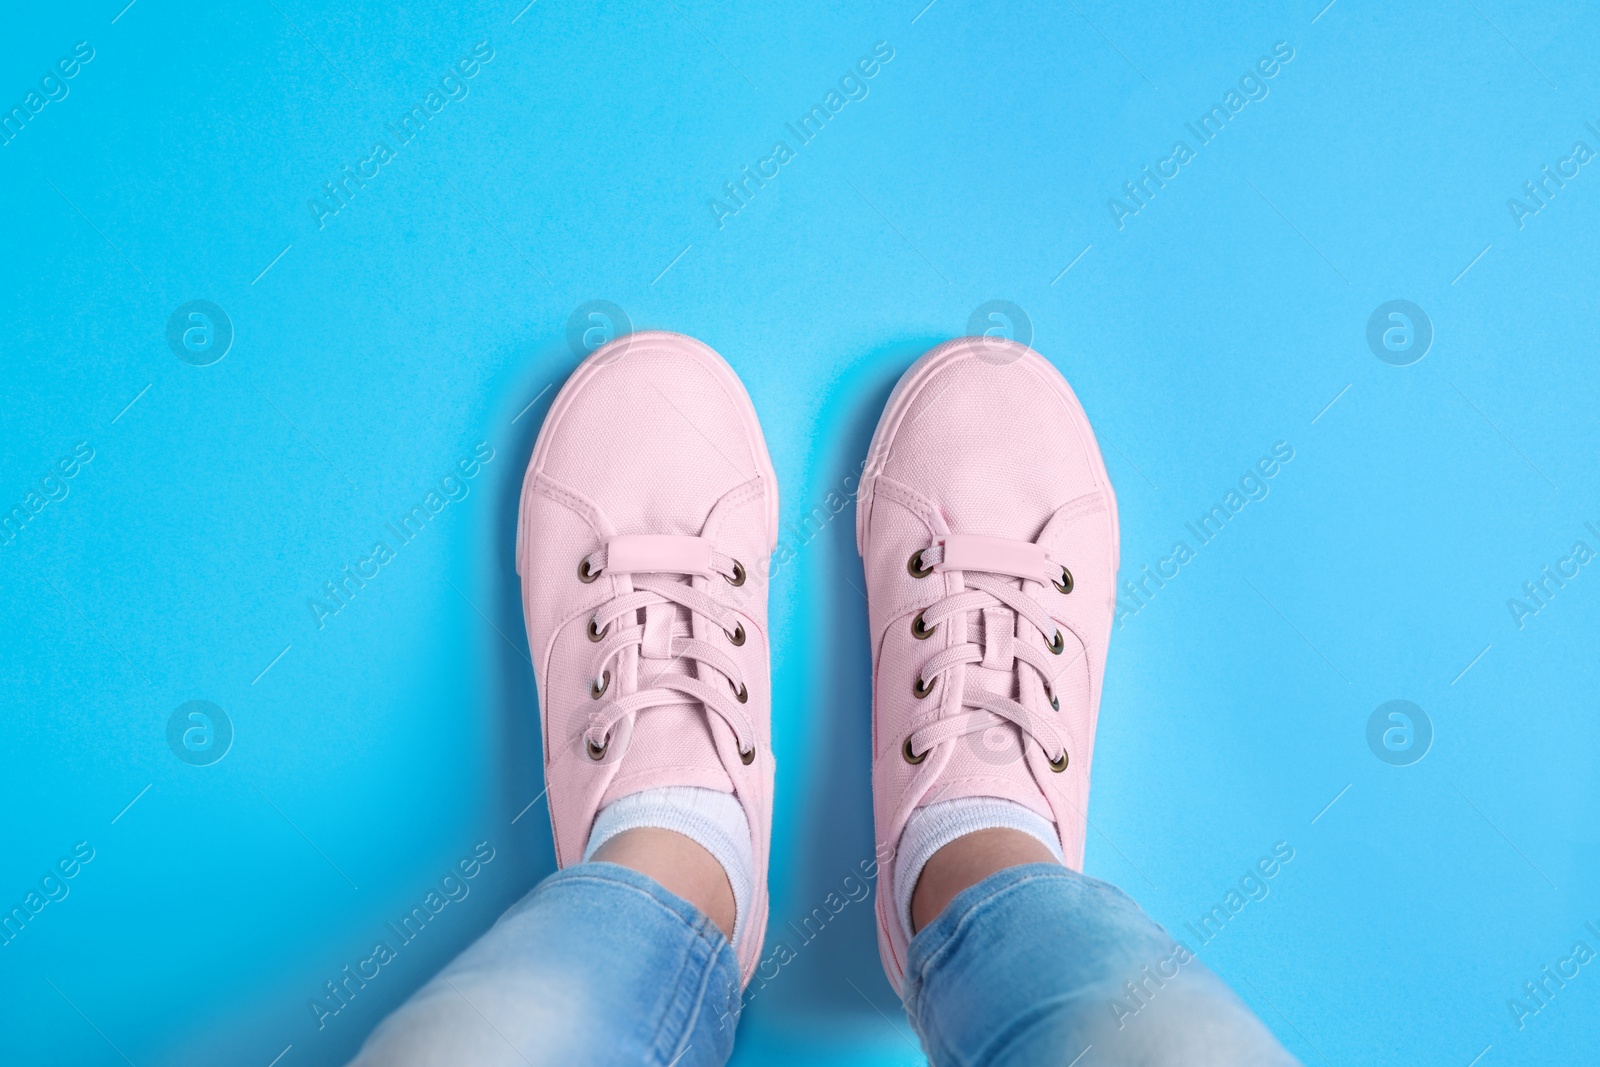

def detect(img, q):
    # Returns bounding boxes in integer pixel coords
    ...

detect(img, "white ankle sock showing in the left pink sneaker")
[584,785,755,945]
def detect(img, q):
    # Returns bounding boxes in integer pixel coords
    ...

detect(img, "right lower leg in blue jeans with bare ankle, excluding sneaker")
[906,830,1296,1067]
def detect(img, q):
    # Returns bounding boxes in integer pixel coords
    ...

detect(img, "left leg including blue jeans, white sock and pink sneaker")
[358,333,778,1067]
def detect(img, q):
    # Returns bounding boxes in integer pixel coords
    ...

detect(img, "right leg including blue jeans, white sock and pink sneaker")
[856,338,1294,1067]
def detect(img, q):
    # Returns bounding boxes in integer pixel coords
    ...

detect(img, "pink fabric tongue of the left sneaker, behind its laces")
[600,591,733,805]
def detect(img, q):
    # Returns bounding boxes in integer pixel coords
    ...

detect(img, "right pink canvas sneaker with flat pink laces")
[856,338,1117,990]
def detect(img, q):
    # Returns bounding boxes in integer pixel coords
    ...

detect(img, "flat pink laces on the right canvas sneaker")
[901,534,1080,777]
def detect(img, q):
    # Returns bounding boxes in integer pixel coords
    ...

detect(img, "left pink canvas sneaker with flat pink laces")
[517,333,778,982]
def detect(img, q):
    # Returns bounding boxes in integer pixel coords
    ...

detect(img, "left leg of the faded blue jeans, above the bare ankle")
[352,853,739,1067]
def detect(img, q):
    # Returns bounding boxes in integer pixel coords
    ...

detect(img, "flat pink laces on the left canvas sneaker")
[578,534,755,765]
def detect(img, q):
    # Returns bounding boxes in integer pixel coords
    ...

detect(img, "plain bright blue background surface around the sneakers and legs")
[0,0,1600,1067]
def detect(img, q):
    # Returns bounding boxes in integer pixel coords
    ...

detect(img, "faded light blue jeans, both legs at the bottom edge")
[352,864,1296,1067]
